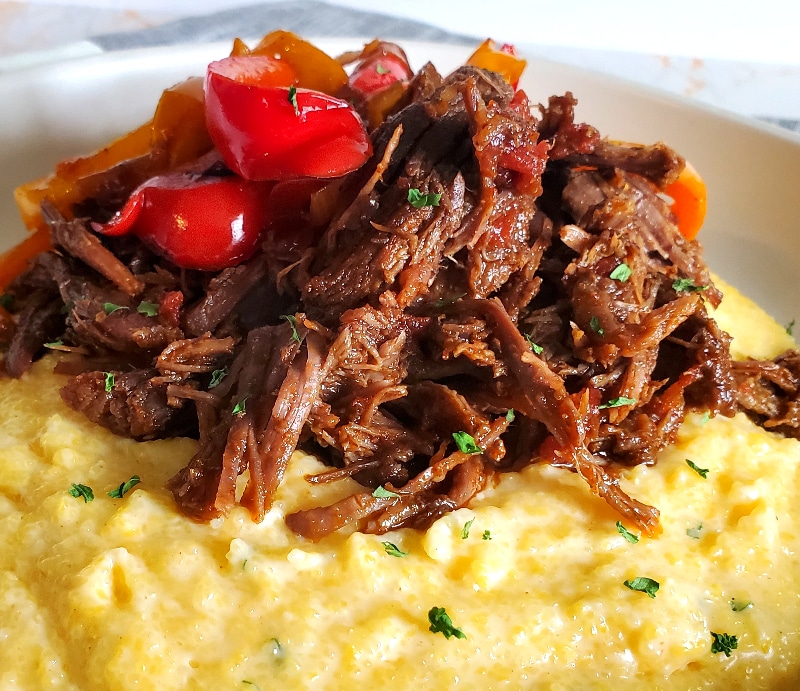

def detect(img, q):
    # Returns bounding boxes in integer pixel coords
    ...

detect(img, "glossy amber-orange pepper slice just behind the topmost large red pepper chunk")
[231,31,347,96]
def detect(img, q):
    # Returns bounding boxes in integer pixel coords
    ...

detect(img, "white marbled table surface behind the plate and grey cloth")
[0,0,800,130]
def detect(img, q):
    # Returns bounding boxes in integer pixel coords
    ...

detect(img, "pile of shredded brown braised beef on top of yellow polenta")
[5,60,800,540]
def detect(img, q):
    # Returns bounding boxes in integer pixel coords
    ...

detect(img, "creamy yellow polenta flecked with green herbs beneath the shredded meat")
[0,278,800,691]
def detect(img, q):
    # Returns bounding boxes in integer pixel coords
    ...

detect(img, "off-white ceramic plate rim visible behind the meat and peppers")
[0,39,800,323]
